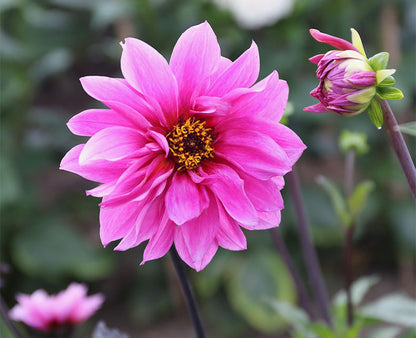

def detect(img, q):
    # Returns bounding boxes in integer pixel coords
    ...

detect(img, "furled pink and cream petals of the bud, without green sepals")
[304,29,377,116]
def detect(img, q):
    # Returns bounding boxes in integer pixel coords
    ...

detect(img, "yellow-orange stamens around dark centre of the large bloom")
[166,118,214,170]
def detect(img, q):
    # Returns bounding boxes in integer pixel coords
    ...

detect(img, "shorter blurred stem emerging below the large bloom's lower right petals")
[269,229,316,320]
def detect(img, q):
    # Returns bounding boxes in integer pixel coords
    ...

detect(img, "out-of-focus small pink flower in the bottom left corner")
[9,283,104,331]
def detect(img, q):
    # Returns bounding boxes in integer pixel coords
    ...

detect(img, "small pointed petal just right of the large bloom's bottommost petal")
[216,201,247,250]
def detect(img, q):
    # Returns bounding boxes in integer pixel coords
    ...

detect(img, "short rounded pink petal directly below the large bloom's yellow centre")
[165,173,208,225]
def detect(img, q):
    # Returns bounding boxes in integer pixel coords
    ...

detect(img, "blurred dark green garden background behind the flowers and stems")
[0,0,416,337]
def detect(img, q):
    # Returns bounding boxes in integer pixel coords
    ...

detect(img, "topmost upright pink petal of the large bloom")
[170,22,221,111]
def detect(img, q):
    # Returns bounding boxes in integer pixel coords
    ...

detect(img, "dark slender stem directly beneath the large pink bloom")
[169,246,205,338]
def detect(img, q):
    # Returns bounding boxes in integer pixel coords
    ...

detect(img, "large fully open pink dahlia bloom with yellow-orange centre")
[61,22,305,271]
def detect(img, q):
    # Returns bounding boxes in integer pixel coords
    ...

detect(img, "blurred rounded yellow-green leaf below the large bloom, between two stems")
[226,249,296,333]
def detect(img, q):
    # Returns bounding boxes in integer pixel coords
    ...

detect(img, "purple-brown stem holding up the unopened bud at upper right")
[377,98,416,200]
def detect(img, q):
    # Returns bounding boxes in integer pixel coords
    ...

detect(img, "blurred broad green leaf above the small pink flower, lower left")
[11,219,112,280]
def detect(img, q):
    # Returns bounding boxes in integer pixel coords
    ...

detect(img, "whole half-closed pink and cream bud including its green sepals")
[304,29,403,126]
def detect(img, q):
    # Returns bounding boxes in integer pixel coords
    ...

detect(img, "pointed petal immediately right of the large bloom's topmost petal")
[208,41,260,97]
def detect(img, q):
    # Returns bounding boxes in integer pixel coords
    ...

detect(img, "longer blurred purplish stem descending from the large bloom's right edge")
[287,167,332,325]
